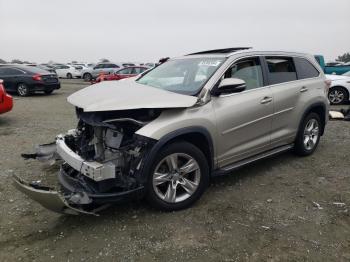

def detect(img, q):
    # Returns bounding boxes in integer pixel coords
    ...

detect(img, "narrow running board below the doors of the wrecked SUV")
[212,144,294,177]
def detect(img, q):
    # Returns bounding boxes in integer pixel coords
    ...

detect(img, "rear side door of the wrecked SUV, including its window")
[265,56,319,147]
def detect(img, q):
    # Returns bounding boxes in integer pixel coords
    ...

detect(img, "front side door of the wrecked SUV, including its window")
[212,57,273,167]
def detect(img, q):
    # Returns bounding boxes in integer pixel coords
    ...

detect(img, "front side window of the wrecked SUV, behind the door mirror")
[224,57,264,90]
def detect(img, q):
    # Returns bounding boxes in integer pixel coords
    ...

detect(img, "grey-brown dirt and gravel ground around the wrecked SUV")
[0,80,350,261]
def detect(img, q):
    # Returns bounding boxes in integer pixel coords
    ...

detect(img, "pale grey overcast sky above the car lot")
[0,0,350,62]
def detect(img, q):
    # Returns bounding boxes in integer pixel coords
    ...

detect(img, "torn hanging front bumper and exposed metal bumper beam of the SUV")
[14,135,144,215]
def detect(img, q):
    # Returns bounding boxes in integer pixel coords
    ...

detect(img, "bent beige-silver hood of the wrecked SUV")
[67,78,197,112]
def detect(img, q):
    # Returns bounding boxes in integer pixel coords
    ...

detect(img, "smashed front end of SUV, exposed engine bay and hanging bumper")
[14,108,161,214]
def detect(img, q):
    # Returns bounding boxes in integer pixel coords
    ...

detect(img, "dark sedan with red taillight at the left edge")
[0,66,61,96]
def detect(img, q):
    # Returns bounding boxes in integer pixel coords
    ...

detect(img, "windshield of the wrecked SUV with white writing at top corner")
[137,57,226,95]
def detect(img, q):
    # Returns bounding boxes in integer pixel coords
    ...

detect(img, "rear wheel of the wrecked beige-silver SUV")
[294,113,323,156]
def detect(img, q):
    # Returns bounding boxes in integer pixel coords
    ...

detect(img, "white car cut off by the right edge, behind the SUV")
[326,72,350,105]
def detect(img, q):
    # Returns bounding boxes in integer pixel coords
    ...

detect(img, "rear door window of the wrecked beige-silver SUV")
[266,56,297,85]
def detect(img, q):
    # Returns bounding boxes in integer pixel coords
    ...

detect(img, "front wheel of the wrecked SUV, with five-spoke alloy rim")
[146,141,209,211]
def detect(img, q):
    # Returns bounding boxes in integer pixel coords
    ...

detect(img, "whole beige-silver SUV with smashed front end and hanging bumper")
[15,48,328,214]
